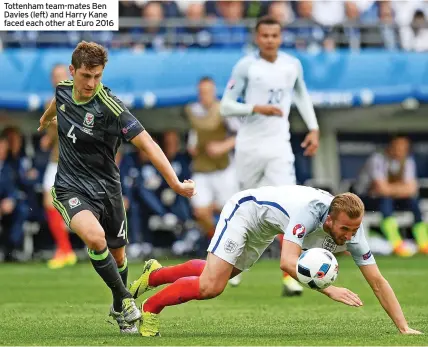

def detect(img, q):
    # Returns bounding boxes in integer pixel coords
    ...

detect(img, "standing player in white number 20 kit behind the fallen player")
[220,17,319,295]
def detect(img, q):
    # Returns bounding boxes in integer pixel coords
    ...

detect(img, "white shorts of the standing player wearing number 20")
[236,153,296,190]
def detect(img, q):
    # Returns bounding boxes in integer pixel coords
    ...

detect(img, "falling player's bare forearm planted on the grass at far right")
[359,264,421,334]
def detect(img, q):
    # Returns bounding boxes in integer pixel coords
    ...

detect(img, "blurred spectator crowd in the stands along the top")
[0,0,428,52]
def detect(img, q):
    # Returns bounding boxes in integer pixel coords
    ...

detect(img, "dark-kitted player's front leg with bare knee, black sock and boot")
[70,210,141,323]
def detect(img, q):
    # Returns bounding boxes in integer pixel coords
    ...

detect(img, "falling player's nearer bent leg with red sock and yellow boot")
[140,253,241,337]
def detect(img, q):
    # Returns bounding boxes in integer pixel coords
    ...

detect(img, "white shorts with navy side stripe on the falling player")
[208,193,276,271]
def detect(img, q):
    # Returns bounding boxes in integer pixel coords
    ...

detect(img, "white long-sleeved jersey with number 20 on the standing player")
[222,53,318,156]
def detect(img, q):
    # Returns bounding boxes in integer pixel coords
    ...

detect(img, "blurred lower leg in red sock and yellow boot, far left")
[43,192,77,269]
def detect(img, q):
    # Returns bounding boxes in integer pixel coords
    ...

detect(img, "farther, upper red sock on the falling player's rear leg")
[149,259,206,287]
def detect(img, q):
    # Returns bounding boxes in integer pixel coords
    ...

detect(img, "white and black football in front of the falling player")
[296,248,339,289]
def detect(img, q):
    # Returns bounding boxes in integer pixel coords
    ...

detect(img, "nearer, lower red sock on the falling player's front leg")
[143,276,200,313]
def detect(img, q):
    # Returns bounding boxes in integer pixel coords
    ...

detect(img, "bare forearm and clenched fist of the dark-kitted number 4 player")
[131,130,196,198]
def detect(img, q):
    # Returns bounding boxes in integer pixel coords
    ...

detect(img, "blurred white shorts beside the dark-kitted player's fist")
[190,164,238,209]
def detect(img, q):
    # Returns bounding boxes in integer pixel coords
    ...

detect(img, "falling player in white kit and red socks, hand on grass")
[130,185,420,336]
